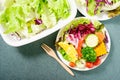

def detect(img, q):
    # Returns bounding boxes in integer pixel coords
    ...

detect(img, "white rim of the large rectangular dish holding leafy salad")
[0,0,77,47]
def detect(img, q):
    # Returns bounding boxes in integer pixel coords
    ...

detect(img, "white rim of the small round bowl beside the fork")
[56,17,111,71]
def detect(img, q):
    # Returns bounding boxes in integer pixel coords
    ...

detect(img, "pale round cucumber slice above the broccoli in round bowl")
[85,34,99,47]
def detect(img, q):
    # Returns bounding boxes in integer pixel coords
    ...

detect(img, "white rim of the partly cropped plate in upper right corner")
[75,0,119,21]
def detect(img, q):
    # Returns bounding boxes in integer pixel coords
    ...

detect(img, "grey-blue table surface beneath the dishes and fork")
[0,13,120,80]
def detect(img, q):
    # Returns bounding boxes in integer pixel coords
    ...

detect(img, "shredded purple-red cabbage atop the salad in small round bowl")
[67,23,95,48]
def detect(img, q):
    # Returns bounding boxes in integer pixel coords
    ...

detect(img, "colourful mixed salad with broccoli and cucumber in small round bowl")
[56,17,109,69]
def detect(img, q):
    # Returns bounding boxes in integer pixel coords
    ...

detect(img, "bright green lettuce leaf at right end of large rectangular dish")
[48,0,70,19]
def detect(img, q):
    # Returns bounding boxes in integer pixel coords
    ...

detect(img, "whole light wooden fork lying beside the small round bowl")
[41,43,74,76]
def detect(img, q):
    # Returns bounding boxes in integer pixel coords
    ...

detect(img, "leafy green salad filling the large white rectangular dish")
[0,0,70,39]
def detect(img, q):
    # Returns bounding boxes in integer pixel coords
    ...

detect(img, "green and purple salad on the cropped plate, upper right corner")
[76,0,120,17]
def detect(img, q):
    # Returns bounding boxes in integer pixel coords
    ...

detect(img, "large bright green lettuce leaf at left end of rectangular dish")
[0,5,25,34]
